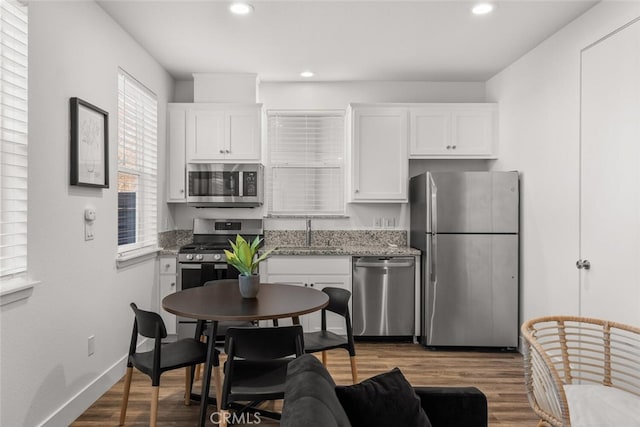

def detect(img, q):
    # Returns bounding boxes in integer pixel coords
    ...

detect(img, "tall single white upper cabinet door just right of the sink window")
[351,108,409,202]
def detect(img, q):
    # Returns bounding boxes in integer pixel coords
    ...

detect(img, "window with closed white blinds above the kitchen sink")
[267,111,345,216]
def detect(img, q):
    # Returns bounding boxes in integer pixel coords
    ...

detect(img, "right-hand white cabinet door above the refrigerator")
[447,106,496,156]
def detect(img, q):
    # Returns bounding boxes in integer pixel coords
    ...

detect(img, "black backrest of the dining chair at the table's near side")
[224,325,304,360]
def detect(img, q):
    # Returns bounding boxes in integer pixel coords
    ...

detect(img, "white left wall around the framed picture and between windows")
[0,1,173,427]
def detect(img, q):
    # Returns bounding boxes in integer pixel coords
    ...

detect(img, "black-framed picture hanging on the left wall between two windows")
[69,98,109,188]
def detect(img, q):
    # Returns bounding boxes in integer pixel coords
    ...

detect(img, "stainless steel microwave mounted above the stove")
[187,163,264,207]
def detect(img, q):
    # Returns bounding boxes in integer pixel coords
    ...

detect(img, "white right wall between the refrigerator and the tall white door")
[487,2,640,326]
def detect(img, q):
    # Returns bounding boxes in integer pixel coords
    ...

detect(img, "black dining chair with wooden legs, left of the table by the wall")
[120,303,207,426]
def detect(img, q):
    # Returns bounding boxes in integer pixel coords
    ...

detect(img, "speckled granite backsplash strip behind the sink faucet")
[264,230,407,247]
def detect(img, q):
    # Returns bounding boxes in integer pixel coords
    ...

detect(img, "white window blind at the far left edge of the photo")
[0,0,28,277]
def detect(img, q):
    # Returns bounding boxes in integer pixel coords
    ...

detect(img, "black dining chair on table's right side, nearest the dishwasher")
[304,287,358,384]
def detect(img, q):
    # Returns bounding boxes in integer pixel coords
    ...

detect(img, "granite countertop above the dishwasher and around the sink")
[261,245,420,256]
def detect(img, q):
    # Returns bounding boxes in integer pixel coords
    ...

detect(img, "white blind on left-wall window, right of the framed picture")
[118,70,158,257]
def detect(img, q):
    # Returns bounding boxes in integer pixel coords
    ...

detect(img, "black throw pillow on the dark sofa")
[336,368,431,427]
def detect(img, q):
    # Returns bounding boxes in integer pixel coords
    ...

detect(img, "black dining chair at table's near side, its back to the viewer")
[220,325,304,419]
